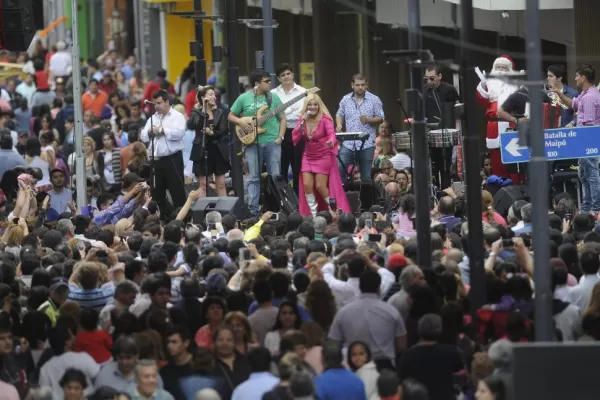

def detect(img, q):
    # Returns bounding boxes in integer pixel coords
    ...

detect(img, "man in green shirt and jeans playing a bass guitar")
[229,70,285,215]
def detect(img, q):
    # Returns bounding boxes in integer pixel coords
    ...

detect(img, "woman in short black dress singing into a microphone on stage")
[188,86,229,196]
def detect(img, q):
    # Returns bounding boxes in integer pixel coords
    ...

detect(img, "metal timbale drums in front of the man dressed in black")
[392,128,462,185]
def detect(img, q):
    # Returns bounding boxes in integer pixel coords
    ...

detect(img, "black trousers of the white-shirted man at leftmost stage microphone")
[152,151,186,217]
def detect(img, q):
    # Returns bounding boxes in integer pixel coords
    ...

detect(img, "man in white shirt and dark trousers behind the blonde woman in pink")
[271,63,306,194]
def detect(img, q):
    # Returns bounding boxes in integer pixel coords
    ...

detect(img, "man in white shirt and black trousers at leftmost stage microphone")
[140,90,186,215]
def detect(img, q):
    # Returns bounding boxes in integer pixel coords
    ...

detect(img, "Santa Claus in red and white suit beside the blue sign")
[477,54,519,178]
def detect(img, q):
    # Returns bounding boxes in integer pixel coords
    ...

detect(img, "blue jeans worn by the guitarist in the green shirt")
[246,142,281,215]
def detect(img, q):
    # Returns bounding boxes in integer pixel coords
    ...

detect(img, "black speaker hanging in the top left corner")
[0,0,36,51]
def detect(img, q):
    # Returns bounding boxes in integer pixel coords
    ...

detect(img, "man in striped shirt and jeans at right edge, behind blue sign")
[551,65,600,214]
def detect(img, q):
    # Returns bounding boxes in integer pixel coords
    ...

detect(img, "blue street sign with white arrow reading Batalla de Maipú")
[500,126,600,164]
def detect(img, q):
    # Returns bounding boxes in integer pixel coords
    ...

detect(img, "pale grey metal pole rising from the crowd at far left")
[71,0,87,214]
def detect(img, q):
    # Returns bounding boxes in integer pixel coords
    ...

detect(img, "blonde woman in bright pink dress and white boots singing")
[292,94,350,217]
